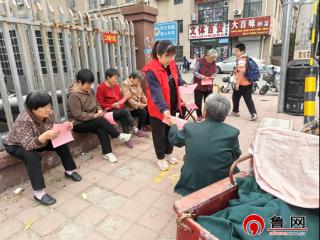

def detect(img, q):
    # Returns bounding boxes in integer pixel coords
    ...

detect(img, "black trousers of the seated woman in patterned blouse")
[4,141,77,191]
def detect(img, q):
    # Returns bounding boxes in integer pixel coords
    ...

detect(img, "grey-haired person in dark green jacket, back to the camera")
[169,93,241,196]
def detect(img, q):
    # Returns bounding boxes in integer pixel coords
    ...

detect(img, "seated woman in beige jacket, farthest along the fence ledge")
[122,71,148,136]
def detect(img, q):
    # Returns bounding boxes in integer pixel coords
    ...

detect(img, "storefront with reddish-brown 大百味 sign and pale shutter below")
[229,16,271,60]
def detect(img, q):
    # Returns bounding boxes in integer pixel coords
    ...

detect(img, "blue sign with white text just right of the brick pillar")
[154,22,179,45]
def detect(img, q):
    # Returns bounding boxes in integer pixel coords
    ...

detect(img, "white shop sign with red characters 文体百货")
[189,21,229,40]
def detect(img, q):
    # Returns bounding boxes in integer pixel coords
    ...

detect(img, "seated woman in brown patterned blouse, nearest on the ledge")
[3,92,81,205]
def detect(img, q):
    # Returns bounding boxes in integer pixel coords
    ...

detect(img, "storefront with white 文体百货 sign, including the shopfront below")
[189,21,231,61]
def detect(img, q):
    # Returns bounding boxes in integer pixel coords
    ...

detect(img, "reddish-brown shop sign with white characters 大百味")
[230,16,271,37]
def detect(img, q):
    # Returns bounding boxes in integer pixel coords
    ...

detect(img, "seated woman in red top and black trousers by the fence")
[97,68,147,148]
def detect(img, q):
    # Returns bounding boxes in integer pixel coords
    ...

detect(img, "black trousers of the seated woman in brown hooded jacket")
[73,117,120,154]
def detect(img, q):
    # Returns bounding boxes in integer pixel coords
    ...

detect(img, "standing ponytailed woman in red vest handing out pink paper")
[143,40,184,171]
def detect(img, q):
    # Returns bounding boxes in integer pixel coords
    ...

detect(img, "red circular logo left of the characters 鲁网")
[242,214,265,236]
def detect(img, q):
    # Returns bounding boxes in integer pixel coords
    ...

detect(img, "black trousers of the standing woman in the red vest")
[150,117,173,160]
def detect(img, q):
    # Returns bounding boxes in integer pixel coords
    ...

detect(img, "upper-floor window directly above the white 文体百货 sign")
[198,0,228,23]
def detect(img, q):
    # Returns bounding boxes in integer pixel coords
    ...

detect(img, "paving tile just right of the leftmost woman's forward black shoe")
[57,197,90,218]
